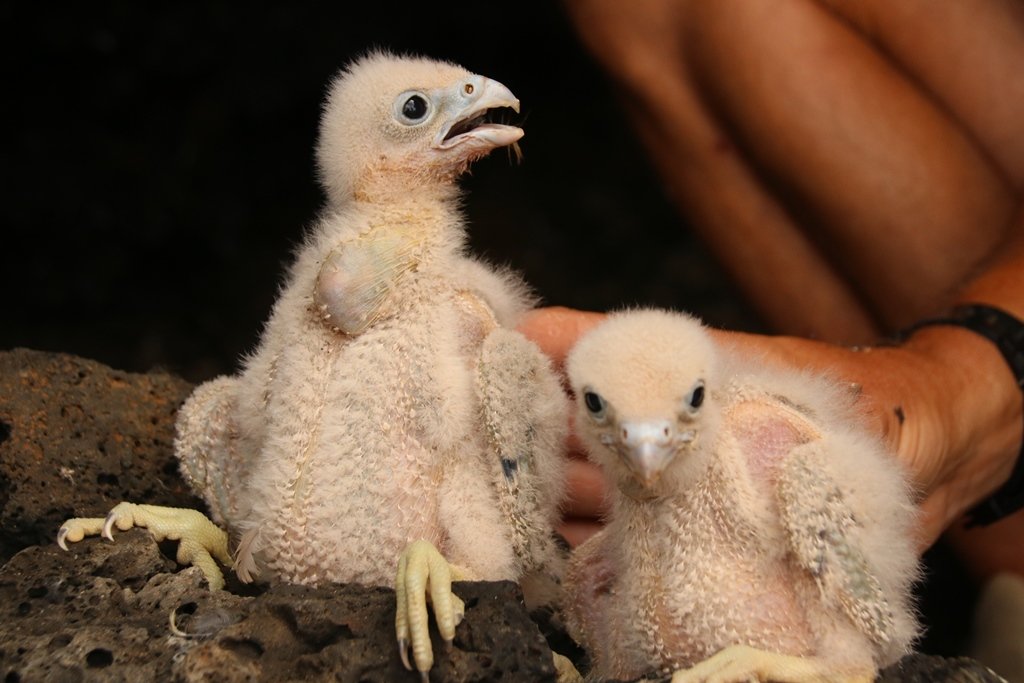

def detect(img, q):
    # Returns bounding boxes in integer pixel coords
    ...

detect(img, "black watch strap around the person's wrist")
[899,303,1024,527]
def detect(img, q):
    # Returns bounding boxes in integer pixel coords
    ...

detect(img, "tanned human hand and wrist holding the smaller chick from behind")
[519,307,1021,550]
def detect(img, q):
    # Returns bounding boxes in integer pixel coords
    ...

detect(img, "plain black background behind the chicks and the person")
[0,0,972,653]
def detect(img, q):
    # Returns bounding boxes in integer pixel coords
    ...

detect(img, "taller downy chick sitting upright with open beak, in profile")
[58,52,568,672]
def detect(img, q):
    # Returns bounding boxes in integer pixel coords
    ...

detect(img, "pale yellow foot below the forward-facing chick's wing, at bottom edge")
[672,645,874,683]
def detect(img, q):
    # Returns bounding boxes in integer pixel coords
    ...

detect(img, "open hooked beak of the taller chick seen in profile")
[433,76,523,153]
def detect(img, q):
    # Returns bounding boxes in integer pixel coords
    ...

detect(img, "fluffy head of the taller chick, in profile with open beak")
[316,52,523,204]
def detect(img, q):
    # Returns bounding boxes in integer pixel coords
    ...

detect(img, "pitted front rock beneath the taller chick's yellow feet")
[0,529,554,683]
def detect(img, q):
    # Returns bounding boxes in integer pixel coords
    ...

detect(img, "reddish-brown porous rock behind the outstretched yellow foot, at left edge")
[0,349,201,562]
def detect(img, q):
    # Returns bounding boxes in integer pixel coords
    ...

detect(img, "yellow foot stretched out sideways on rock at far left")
[57,503,231,591]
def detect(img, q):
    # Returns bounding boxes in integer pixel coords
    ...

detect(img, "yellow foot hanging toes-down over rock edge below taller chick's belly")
[394,541,468,681]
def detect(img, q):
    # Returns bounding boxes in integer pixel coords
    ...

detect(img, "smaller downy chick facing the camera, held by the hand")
[565,310,918,682]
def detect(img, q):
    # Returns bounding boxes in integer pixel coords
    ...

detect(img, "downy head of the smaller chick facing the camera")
[566,310,719,500]
